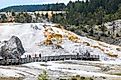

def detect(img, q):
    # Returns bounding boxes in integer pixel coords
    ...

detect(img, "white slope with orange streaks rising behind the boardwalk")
[0,23,121,60]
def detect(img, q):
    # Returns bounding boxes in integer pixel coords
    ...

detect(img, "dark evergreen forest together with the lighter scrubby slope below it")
[51,0,121,40]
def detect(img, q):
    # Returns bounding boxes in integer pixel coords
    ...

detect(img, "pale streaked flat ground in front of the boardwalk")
[0,60,121,80]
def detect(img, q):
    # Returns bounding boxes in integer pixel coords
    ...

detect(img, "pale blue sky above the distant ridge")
[0,0,76,9]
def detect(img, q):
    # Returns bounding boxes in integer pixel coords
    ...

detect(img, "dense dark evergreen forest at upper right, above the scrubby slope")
[53,0,121,25]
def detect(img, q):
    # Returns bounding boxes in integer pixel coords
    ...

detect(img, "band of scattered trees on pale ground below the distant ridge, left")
[0,12,50,23]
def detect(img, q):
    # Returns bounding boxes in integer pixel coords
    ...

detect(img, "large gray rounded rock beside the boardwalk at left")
[0,36,25,59]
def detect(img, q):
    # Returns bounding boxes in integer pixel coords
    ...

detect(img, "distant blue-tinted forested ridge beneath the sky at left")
[0,3,65,12]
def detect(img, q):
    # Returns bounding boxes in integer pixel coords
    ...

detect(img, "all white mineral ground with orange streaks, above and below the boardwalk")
[0,23,121,80]
